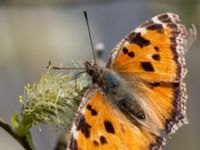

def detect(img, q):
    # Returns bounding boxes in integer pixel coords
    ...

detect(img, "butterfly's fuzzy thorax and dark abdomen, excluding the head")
[98,69,145,120]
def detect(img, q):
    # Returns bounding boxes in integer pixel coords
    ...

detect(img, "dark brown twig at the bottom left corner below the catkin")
[0,119,32,150]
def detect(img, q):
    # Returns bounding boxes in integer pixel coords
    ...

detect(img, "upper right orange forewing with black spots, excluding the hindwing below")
[107,13,187,81]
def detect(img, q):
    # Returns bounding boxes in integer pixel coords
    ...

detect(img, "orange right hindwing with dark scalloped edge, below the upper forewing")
[132,82,187,134]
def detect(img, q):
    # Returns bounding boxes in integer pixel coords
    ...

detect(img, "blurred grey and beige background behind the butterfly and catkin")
[0,0,200,150]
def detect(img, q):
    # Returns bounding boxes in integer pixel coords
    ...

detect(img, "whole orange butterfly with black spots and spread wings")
[67,13,195,150]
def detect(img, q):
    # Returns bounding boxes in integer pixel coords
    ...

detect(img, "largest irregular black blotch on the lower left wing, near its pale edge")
[77,115,91,138]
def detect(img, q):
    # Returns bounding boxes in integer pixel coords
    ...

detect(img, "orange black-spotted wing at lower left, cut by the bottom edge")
[67,87,165,150]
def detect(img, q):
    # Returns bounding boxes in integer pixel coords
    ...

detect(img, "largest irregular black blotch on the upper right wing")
[126,32,151,48]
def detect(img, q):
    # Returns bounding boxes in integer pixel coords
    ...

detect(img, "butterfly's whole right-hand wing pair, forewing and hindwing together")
[107,13,188,133]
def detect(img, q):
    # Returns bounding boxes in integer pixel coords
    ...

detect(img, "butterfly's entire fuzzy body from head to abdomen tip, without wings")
[85,61,145,119]
